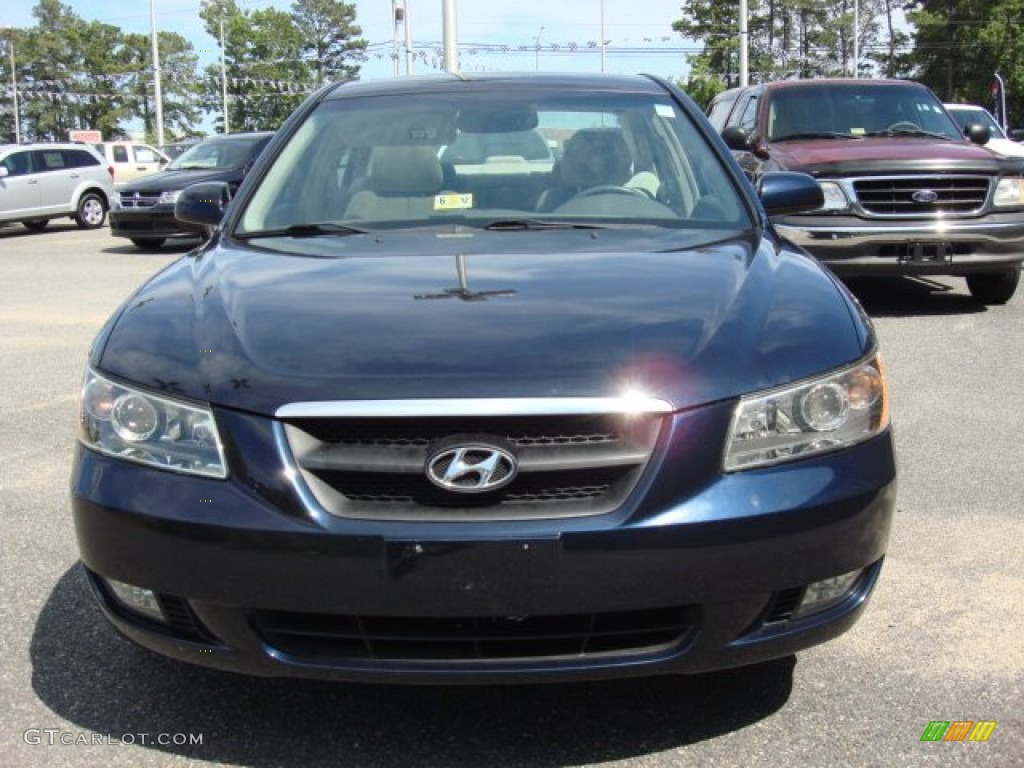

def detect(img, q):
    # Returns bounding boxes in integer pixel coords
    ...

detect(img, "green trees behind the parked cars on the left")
[0,0,367,140]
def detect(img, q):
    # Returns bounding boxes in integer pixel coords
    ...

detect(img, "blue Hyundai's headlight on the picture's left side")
[79,370,227,477]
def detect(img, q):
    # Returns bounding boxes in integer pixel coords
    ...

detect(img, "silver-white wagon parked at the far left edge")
[0,143,114,230]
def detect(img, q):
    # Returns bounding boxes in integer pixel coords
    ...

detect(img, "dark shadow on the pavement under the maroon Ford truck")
[843,276,986,317]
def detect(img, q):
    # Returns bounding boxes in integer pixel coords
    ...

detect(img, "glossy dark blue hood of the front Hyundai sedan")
[92,232,873,414]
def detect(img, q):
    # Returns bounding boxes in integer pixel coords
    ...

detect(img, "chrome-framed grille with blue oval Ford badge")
[853,176,989,217]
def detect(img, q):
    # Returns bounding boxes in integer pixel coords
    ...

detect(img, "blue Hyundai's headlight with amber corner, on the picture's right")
[722,357,889,472]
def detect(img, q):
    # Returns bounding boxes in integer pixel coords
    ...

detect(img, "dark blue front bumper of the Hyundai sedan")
[72,403,895,683]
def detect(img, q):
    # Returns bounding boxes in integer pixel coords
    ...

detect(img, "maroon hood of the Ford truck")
[769,136,1004,175]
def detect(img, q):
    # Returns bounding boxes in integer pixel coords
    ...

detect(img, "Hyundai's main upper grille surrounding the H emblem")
[280,405,665,520]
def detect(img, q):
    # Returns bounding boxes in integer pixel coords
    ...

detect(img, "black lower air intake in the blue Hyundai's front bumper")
[253,606,695,664]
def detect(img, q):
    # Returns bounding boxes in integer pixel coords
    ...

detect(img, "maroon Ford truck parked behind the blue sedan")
[709,79,1024,304]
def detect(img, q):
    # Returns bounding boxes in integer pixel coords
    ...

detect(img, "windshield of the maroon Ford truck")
[767,81,962,141]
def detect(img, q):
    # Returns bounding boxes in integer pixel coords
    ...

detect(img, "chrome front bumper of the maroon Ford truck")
[775,212,1024,276]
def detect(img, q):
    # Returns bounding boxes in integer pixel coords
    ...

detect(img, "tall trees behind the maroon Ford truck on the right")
[673,0,1024,126]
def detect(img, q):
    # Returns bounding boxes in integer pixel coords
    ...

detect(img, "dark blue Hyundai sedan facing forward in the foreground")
[71,74,896,683]
